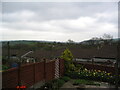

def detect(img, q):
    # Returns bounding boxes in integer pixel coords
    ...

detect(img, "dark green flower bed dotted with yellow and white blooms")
[65,68,117,84]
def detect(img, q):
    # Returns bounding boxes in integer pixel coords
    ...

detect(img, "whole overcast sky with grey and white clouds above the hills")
[0,2,118,42]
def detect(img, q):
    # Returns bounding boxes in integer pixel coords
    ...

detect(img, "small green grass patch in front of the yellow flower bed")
[73,79,100,86]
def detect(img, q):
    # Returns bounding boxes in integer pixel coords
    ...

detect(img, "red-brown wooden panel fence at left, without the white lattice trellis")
[2,59,64,88]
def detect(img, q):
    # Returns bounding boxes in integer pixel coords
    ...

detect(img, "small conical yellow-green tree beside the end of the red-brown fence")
[61,48,75,72]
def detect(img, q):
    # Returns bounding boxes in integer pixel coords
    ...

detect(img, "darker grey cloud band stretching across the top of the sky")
[3,2,117,20]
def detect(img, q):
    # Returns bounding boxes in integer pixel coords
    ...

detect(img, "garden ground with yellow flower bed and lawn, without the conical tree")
[41,68,120,90]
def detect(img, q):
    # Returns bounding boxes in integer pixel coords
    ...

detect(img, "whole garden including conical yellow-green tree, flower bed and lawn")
[38,49,120,90]
